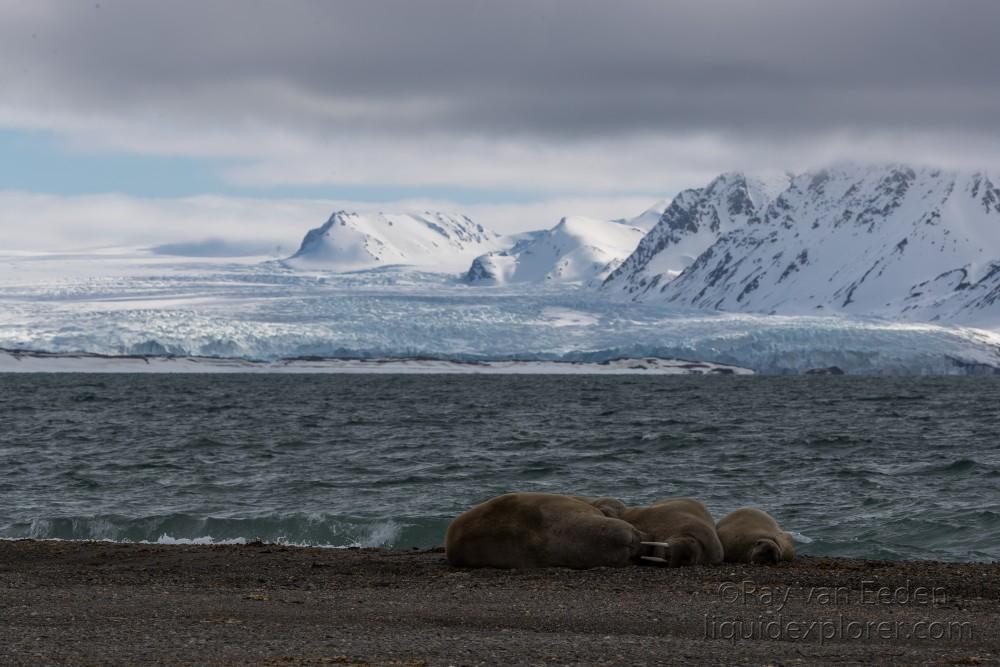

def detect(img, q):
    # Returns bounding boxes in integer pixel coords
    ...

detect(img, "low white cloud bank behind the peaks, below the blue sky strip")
[0,191,653,255]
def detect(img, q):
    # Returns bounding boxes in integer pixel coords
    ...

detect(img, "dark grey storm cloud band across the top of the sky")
[0,0,1000,142]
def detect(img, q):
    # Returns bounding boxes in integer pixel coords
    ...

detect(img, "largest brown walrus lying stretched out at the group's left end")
[445,493,644,569]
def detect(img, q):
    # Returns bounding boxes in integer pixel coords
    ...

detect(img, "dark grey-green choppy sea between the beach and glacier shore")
[0,375,1000,560]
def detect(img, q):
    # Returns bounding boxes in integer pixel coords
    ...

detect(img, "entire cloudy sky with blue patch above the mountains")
[0,0,1000,246]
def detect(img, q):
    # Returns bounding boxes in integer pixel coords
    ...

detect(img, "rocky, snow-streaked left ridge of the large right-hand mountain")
[605,173,787,297]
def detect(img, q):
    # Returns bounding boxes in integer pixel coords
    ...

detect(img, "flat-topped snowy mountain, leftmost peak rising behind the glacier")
[285,211,500,272]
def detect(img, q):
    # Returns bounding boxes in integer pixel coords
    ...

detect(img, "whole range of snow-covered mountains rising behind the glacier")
[256,165,1000,329]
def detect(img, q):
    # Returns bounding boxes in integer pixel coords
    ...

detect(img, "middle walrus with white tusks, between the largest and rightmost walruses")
[621,498,723,567]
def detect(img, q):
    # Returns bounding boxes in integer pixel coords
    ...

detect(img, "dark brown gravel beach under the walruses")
[0,540,1000,666]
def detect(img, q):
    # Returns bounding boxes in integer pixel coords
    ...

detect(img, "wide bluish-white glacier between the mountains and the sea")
[0,256,1000,373]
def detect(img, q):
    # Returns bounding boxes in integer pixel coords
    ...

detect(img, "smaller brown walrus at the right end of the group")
[716,507,795,563]
